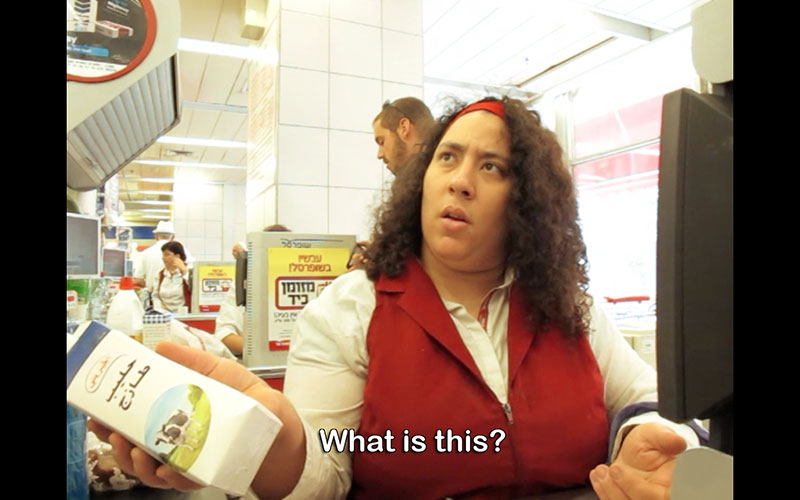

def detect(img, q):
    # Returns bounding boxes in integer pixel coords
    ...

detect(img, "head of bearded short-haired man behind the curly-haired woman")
[372,97,434,174]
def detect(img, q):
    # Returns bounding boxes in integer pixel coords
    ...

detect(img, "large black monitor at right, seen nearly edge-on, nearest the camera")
[656,82,733,455]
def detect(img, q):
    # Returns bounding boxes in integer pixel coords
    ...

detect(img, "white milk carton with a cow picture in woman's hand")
[67,321,282,496]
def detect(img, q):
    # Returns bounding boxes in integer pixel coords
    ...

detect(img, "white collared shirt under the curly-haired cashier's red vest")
[284,270,698,499]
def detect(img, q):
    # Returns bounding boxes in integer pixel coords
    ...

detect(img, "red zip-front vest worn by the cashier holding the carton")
[350,259,609,500]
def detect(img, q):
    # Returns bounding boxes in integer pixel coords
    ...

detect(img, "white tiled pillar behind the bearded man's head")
[247,0,423,244]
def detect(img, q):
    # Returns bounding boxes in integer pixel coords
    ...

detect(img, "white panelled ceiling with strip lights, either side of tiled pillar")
[114,0,708,224]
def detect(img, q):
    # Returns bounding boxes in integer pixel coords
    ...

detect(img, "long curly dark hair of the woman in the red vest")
[365,97,591,337]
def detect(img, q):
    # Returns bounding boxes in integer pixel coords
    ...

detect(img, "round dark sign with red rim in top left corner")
[67,0,156,83]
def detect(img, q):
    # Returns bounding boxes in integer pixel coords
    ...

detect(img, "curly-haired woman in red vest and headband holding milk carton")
[89,98,698,500]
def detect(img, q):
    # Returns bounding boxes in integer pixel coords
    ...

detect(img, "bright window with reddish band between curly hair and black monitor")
[569,29,698,312]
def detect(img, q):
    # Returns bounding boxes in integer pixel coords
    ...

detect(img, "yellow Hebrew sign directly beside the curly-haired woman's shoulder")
[267,248,350,351]
